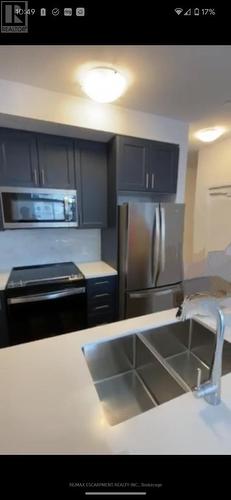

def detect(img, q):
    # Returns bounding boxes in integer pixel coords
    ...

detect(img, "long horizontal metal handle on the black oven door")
[7,287,86,305]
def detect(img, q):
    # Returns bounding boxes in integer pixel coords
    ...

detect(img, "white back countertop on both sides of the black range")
[0,260,117,290]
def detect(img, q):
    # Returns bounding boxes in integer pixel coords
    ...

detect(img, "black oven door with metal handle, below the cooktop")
[7,287,87,345]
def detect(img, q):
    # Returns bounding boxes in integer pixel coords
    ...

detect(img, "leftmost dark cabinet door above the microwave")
[0,129,39,187]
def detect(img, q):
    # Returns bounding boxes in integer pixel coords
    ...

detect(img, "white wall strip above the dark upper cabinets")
[0,80,188,203]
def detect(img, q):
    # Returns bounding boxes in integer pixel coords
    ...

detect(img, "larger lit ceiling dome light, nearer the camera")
[81,67,127,102]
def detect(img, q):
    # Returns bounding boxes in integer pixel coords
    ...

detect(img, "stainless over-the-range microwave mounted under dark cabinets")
[0,187,78,229]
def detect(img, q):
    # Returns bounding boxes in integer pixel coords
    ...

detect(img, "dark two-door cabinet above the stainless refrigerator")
[116,136,179,193]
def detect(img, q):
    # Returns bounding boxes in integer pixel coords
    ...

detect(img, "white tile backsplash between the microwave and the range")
[0,228,101,271]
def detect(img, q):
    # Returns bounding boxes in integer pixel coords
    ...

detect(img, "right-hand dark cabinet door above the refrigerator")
[149,142,179,193]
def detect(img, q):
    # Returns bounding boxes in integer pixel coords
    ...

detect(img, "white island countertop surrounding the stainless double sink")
[0,309,231,455]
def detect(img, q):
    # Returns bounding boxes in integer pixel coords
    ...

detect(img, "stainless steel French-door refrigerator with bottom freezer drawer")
[119,202,184,319]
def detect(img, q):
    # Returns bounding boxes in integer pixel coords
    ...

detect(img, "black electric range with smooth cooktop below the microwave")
[6,262,86,345]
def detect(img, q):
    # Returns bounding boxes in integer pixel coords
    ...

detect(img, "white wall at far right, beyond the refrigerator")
[192,135,231,280]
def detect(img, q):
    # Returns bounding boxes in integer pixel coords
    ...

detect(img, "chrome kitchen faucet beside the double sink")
[177,292,231,405]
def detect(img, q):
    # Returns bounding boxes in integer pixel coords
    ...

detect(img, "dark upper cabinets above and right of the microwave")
[0,128,107,228]
